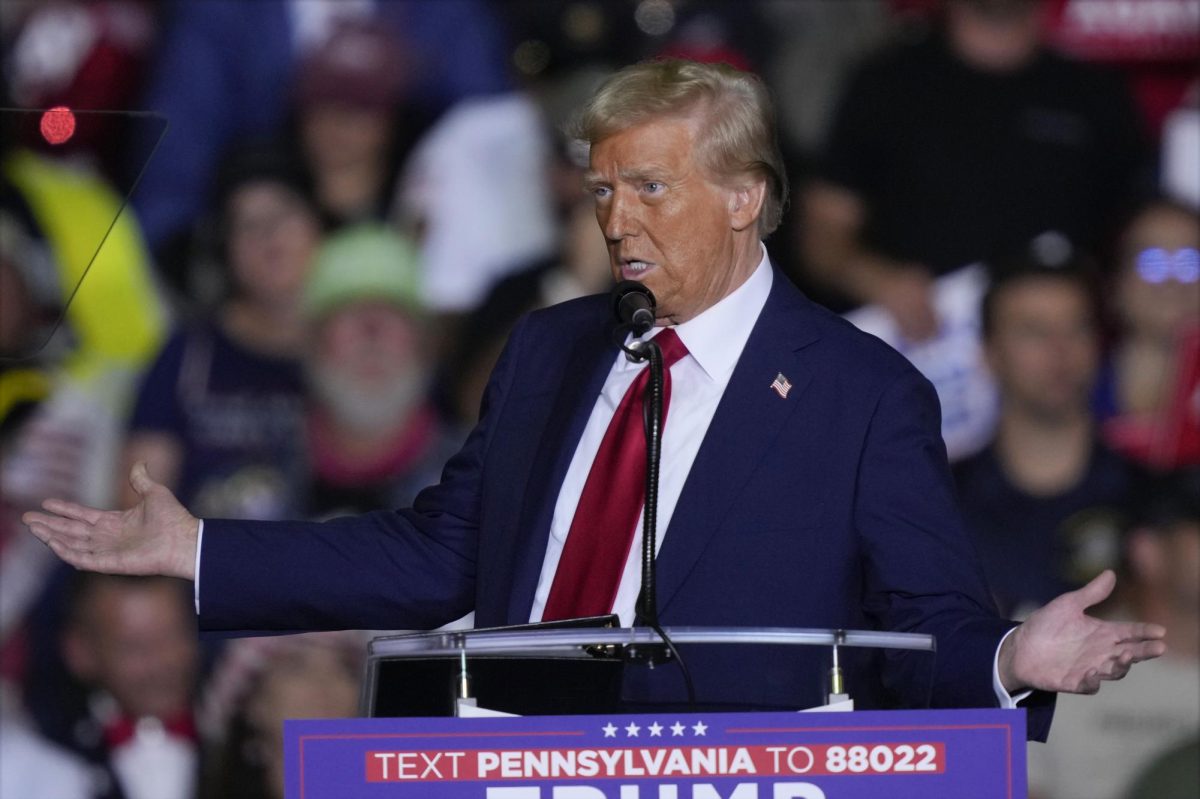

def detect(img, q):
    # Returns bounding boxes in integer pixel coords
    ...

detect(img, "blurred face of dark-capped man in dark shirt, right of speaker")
[988,278,1097,419]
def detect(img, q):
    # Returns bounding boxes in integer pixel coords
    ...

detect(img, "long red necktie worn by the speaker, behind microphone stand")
[541,328,688,621]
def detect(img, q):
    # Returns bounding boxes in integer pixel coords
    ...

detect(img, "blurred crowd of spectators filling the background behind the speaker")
[0,0,1200,799]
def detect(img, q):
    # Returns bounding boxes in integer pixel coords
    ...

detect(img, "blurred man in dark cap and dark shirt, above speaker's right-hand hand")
[955,265,1134,618]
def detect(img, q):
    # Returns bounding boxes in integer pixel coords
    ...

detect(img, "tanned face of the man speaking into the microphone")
[584,118,757,324]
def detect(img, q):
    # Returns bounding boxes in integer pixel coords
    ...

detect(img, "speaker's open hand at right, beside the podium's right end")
[998,570,1166,693]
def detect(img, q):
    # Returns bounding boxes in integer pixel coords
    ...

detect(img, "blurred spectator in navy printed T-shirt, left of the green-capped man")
[118,149,320,518]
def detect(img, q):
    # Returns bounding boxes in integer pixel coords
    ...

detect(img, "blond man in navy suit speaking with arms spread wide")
[25,61,1164,737]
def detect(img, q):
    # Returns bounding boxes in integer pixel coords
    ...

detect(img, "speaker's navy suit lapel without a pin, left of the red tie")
[508,321,618,624]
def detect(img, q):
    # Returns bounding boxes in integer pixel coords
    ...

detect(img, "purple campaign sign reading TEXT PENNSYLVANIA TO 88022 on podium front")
[283,709,1026,799]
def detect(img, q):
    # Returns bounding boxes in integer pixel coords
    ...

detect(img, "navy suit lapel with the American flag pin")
[658,272,817,611]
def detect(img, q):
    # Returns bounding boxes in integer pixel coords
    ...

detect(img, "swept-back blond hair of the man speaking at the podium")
[570,59,787,238]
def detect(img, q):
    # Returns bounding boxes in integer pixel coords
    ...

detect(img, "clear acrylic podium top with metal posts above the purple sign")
[361,625,936,716]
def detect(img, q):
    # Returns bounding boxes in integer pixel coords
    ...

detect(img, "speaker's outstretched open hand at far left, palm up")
[22,463,199,579]
